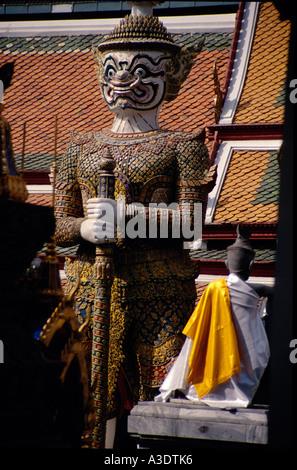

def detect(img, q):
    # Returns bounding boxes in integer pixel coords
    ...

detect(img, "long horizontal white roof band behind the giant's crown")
[0,13,236,37]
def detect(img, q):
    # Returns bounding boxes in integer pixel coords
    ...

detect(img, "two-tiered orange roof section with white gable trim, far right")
[207,2,290,235]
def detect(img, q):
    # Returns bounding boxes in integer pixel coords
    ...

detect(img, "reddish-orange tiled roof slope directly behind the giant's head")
[0,33,232,170]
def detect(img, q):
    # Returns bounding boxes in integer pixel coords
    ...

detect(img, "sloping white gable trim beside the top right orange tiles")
[219,2,259,124]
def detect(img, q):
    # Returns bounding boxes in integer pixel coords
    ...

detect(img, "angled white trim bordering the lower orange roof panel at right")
[205,140,282,224]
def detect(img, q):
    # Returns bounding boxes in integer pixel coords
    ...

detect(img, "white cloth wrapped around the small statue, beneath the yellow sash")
[155,273,270,408]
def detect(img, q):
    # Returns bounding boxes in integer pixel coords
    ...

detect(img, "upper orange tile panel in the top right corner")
[234,2,290,123]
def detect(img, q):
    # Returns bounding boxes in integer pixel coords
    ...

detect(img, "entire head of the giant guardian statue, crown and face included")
[93,2,203,116]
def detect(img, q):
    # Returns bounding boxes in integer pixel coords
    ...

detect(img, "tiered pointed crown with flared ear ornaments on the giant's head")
[93,1,204,101]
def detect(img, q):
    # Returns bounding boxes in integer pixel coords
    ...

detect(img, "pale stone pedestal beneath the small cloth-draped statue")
[128,399,268,444]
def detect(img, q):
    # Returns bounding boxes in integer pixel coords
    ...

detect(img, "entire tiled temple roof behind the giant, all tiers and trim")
[0,2,290,280]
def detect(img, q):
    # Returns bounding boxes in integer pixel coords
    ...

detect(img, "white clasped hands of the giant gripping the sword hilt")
[80,198,117,244]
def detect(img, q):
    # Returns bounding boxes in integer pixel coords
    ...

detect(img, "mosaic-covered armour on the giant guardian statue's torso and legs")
[56,126,213,416]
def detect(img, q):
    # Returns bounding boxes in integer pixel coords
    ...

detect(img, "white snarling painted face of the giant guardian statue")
[100,51,171,111]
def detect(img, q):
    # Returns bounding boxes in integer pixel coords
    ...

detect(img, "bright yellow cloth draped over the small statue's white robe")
[183,279,241,398]
